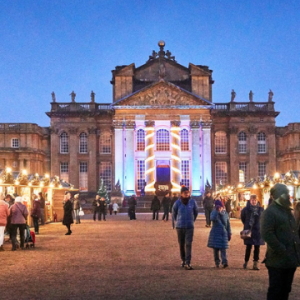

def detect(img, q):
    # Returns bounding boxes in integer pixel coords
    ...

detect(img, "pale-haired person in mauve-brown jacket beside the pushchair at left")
[10,196,28,251]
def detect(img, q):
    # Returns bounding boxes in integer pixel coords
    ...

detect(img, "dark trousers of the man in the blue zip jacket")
[176,228,194,264]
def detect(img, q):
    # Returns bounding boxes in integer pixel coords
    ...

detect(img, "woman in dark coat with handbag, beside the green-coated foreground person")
[241,195,265,270]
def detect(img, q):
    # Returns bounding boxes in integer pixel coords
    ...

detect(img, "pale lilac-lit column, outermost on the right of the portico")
[202,121,212,186]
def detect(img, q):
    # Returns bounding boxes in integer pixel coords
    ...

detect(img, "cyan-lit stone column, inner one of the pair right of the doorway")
[190,121,204,196]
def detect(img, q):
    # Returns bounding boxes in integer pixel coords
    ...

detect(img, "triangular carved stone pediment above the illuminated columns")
[114,80,211,106]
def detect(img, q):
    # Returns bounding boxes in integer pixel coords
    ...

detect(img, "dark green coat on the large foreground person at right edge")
[261,199,300,269]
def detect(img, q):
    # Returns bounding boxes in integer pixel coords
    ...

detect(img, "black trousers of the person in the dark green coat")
[267,267,296,300]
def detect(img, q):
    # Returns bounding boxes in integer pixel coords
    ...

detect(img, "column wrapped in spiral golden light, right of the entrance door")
[171,121,181,192]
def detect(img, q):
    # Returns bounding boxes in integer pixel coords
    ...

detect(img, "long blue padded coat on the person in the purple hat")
[207,209,231,249]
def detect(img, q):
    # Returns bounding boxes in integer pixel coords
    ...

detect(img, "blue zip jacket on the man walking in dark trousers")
[172,199,198,228]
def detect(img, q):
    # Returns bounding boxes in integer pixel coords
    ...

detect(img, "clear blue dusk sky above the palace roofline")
[0,0,300,126]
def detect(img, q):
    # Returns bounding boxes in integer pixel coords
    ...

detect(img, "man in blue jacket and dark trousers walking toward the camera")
[172,186,198,270]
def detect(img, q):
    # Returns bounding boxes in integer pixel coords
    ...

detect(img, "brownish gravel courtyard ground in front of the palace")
[0,213,300,300]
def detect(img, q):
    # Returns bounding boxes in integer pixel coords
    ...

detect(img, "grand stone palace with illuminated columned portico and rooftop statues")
[0,41,300,196]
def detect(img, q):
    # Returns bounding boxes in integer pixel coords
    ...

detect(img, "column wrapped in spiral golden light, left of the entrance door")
[145,121,155,195]
